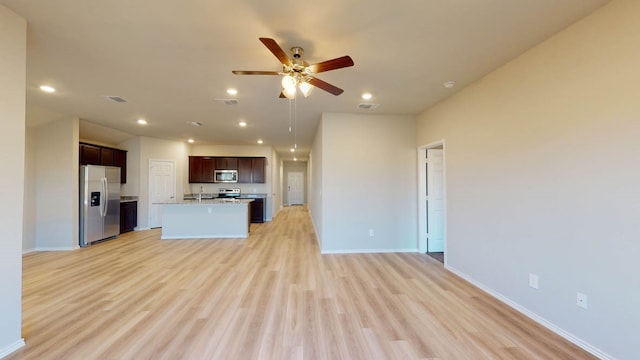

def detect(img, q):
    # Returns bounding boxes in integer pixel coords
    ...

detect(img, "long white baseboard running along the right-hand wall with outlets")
[444,265,615,360]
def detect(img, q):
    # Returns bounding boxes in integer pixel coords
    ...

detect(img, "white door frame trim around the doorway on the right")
[417,139,447,258]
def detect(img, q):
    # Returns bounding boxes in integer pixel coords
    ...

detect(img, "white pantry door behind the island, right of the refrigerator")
[149,160,176,228]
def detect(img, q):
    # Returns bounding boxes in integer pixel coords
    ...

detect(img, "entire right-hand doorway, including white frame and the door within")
[418,140,447,263]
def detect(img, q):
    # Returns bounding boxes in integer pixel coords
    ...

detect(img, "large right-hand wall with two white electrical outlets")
[418,0,640,359]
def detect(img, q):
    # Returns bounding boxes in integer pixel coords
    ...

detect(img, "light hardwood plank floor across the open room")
[7,207,593,360]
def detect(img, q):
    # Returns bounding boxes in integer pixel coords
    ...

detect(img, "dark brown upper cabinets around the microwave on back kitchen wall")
[189,156,266,184]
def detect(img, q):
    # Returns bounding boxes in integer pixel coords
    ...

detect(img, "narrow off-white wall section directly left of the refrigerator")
[35,118,79,250]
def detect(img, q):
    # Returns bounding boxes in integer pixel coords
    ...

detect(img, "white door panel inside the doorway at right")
[426,149,444,252]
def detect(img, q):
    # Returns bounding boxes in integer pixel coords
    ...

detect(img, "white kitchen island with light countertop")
[161,199,253,239]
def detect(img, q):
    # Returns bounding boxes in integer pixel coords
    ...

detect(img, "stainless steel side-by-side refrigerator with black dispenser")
[80,165,120,247]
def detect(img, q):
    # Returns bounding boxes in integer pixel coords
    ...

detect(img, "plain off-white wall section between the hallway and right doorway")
[312,113,417,253]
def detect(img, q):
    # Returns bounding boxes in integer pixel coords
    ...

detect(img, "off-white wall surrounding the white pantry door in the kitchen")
[134,137,189,229]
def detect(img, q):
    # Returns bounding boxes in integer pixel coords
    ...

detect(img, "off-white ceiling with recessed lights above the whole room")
[0,0,607,159]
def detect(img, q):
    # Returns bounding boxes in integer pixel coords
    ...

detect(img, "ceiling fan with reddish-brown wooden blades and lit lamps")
[233,38,353,99]
